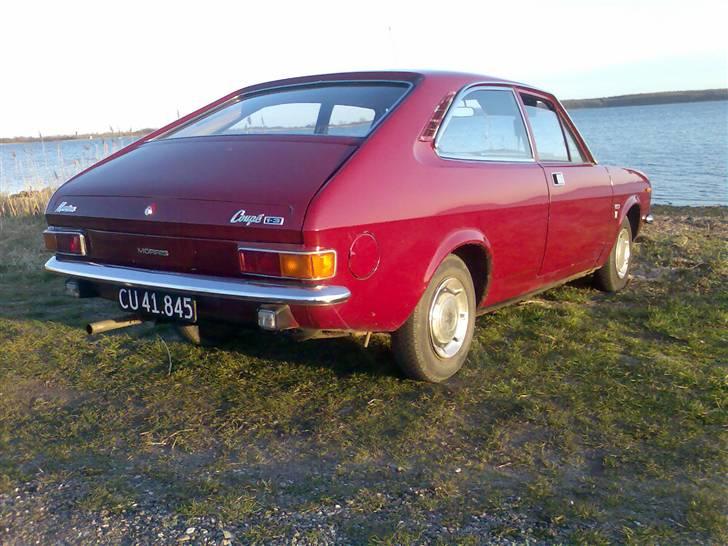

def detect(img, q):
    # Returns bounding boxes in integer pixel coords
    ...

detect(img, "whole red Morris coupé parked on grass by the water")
[45,72,651,381]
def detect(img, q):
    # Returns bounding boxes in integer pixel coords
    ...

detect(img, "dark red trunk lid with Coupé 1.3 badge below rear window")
[47,136,361,243]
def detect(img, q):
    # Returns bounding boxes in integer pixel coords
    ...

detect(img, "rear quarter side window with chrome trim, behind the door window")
[435,88,533,161]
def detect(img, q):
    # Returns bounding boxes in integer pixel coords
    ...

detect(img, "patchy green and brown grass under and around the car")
[0,207,728,544]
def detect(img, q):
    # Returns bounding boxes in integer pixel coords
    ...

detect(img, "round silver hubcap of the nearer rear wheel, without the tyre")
[430,277,469,358]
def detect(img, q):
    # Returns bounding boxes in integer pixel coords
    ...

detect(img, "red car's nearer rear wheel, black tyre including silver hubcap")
[392,254,475,383]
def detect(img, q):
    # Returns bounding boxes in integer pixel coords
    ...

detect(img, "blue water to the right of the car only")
[570,101,728,205]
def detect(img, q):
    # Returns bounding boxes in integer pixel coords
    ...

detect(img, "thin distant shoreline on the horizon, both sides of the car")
[0,88,728,144]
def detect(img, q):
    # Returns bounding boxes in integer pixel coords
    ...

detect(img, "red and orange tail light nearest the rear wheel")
[239,248,336,280]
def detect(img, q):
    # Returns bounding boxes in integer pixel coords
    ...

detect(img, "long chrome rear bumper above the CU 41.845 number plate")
[45,257,351,305]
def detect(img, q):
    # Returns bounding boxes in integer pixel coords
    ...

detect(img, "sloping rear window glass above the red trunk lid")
[162,82,409,138]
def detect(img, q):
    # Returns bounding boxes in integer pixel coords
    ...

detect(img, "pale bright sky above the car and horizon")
[0,0,728,137]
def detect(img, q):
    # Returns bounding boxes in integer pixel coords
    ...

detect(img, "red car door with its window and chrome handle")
[520,92,614,280]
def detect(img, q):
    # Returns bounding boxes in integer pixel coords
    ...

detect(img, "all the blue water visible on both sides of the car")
[0,101,728,205]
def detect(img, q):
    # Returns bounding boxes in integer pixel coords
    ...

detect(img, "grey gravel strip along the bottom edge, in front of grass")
[0,474,546,546]
